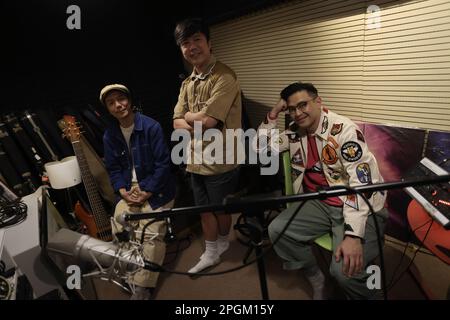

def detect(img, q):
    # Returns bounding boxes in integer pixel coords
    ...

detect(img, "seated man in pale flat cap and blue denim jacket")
[100,84,175,299]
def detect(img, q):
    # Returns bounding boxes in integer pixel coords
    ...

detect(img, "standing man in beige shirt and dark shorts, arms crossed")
[173,19,242,273]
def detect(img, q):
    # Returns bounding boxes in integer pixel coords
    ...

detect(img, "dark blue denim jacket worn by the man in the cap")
[103,113,175,209]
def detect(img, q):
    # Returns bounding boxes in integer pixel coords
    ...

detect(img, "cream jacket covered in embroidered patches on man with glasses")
[258,107,386,238]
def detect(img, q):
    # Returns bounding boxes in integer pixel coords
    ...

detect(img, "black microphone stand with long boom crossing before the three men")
[125,174,450,299]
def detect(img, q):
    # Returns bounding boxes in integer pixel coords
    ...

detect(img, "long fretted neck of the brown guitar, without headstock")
[72,141,110,228]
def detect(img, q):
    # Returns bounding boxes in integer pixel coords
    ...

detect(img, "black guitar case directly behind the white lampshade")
[34,109,73,159]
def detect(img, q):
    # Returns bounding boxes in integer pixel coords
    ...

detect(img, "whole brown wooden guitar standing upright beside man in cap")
[58,115,112,241]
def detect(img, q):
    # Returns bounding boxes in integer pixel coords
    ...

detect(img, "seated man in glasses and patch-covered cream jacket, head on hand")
[259,82,388,299]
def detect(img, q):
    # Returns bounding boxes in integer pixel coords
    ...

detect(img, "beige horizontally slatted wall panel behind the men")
[211,0,450,130]
